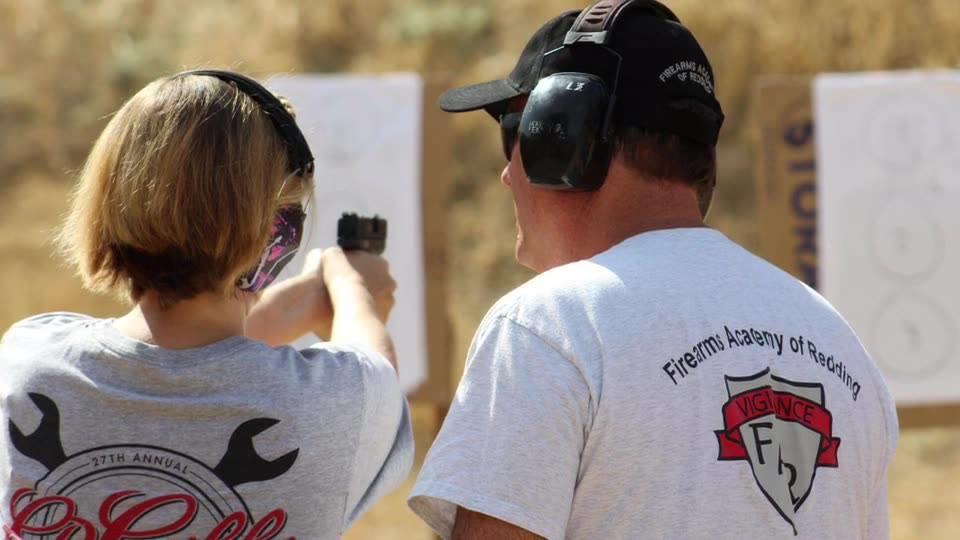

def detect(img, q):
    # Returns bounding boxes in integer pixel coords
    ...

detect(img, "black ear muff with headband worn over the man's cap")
[519,0,677,191]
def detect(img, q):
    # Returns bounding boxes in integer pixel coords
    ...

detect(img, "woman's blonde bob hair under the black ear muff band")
[57,74,312,306]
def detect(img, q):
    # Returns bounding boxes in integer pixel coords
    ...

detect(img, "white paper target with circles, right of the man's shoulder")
[814,71,960,405]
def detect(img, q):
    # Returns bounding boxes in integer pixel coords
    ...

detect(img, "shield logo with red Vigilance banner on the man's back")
[716,368,840,534]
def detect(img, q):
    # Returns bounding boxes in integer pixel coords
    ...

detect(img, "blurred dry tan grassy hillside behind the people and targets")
[0,0,960,539]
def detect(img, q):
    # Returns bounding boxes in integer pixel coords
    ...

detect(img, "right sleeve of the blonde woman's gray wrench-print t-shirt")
[343,355,414,530]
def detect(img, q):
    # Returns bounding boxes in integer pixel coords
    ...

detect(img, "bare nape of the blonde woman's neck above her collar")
[115,291,248,349]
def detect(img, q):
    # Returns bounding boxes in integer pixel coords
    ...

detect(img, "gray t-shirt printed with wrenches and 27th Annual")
[0,313,413,539]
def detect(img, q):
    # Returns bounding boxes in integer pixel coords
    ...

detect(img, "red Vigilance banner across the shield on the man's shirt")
[716,386,840,467]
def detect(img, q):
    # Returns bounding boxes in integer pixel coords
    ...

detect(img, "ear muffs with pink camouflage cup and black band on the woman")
[176,69,314,292]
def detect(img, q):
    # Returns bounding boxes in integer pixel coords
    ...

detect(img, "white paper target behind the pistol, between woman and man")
[267,74,427,393]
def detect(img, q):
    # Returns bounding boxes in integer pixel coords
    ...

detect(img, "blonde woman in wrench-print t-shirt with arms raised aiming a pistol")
[0,71,413,540]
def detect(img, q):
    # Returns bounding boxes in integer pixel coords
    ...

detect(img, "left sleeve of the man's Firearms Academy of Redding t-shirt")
[409,317,590,538]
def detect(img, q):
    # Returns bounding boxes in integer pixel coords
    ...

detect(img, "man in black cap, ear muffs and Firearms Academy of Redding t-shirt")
[410,1,898,539]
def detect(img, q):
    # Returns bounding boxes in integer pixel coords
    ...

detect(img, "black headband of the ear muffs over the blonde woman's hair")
[174,69,313,176]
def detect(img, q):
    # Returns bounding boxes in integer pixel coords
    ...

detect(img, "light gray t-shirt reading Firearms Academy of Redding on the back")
[410,229,897,540]
